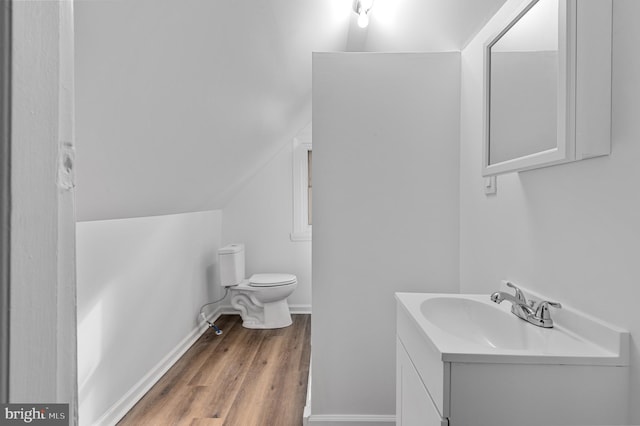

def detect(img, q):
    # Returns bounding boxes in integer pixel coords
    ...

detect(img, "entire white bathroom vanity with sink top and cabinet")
[396,292,629,426]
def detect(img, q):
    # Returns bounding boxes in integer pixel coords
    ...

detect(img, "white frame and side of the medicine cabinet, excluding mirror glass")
[482,0,612,176]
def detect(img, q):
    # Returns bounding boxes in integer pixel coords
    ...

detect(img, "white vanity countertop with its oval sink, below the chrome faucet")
[396,293,629,365]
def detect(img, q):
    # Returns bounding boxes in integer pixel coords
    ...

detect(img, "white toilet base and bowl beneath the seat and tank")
[231,289,293,329]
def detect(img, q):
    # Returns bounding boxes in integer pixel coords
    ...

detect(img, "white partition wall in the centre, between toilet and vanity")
[311,53,460,424]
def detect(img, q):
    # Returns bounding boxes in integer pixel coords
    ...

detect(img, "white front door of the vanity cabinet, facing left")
[396,340,449,426]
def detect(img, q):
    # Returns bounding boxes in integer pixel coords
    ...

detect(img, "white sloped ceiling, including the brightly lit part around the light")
[74,0,505,220]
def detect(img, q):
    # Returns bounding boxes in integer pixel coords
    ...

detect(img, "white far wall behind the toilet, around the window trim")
[222,141,311,312]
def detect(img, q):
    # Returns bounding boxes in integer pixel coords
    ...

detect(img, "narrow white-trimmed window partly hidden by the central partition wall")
[291,133,313,241]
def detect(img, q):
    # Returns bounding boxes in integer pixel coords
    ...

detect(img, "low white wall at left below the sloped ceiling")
[77,211,222,425]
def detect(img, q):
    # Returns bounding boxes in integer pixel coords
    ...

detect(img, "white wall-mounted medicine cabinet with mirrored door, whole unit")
[483,0,611,176]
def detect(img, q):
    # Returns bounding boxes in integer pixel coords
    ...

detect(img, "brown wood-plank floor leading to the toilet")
[118,315,311,426]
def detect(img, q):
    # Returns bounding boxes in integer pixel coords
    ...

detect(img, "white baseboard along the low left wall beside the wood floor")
[94,308,224,426]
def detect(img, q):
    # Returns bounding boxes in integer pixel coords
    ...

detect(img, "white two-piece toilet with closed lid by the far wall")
[218,244,298,329]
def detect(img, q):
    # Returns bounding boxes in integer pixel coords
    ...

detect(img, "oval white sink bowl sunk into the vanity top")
[420,297,541,349]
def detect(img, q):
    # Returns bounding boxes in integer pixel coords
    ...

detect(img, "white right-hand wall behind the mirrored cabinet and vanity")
[460,0,640,423]
